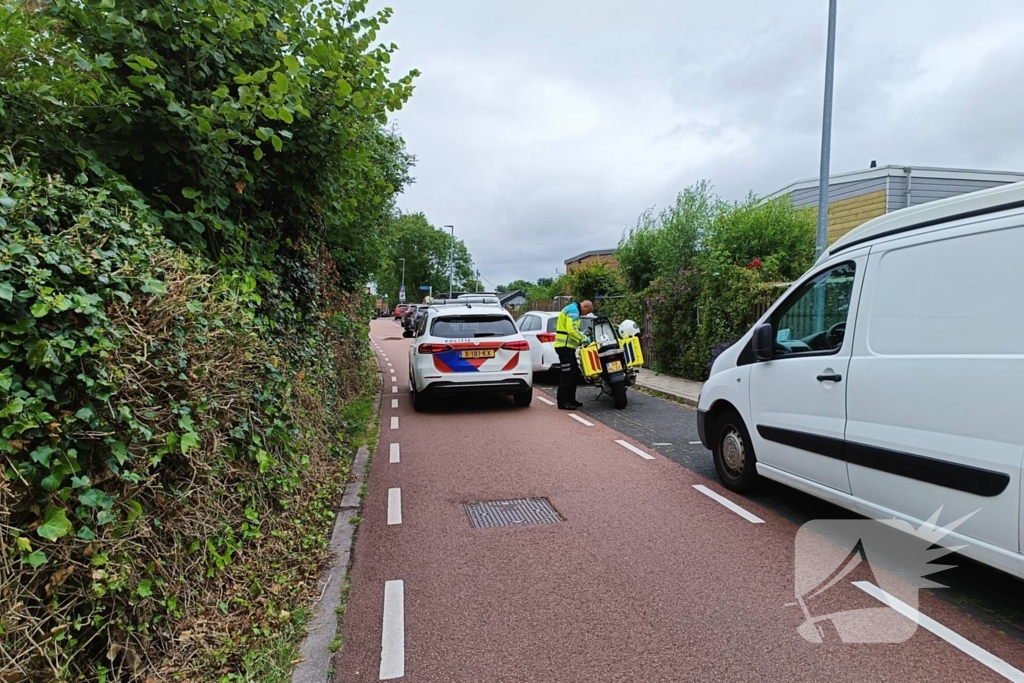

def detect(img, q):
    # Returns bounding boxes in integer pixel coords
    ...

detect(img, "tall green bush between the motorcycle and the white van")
[618,182,815,379]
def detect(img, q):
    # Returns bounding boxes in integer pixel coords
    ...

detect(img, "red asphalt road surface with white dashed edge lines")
[334,321,1024,683]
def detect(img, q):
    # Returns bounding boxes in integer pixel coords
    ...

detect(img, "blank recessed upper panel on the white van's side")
[867,226,1024,355]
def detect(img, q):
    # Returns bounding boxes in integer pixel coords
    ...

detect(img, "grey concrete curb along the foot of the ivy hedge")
[292,362,384,683]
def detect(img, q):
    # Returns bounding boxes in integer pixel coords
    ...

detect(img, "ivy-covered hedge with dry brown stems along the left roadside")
[0,165,372,680]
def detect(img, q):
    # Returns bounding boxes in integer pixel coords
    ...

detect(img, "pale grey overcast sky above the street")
[371,0,1024,285]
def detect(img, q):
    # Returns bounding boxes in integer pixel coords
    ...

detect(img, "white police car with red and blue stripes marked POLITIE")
[409,297,534,411]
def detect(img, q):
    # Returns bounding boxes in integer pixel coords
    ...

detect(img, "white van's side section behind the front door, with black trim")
[846,222,1024,551]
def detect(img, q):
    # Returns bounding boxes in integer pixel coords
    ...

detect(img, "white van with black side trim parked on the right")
[697,183,1024,578]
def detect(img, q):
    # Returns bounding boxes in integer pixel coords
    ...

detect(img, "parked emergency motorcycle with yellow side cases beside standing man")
[577,315,643,410]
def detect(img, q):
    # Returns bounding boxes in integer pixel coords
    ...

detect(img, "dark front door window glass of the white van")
[772,261,856,356]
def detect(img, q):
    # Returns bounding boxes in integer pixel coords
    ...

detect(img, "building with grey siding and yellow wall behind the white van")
[770,162,1024,245]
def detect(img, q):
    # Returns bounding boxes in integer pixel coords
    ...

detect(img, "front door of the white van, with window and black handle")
[750,248,867,494]
